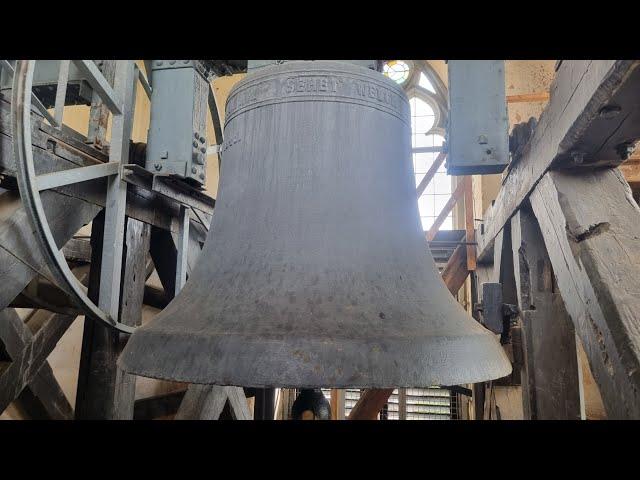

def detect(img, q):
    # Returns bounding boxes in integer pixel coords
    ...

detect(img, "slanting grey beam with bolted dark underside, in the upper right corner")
[478,60,640,259]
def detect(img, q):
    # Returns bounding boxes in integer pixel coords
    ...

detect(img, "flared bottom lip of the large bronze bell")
[118,329,512,388]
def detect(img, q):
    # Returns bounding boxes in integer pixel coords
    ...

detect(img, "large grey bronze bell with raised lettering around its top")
[119,61,511,388]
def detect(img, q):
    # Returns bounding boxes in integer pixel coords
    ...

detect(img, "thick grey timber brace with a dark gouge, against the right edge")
[530,168,640,419]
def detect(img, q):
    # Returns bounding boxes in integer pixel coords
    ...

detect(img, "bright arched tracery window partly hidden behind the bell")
[383,60,453,231]
